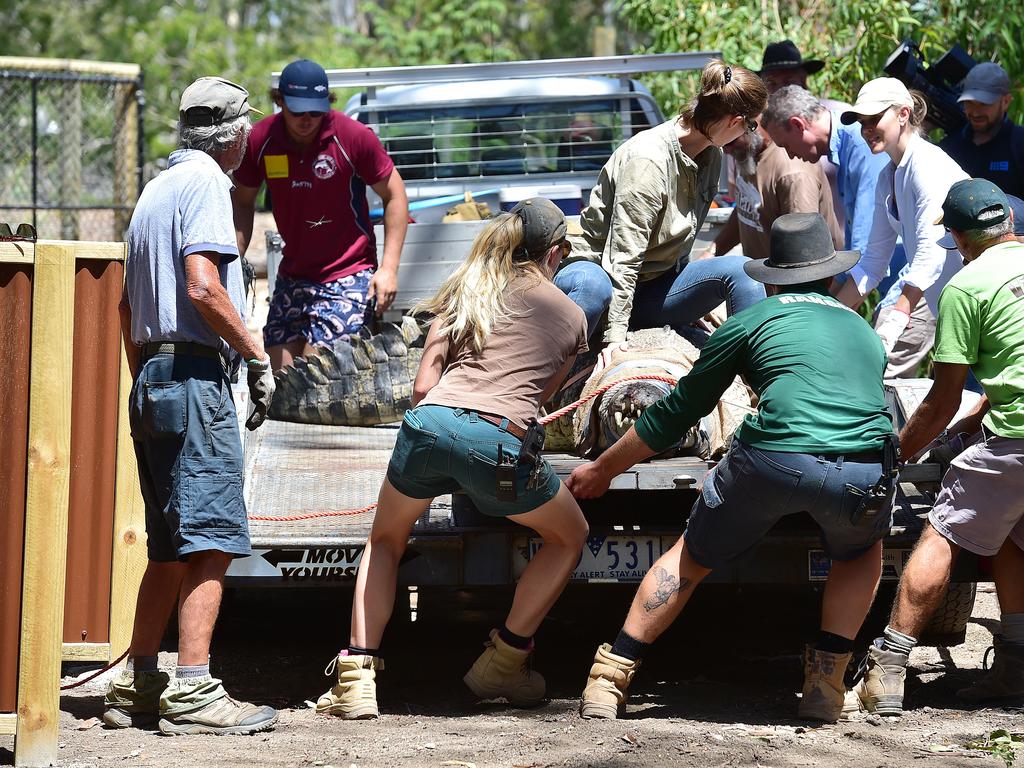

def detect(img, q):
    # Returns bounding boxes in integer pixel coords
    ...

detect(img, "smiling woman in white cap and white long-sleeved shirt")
[838,78,968,375]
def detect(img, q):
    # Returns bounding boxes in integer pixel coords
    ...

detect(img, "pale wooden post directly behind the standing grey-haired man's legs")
[111,256,148,658]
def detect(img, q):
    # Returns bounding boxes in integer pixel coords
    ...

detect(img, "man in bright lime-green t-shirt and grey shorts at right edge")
[856,179,1024,715]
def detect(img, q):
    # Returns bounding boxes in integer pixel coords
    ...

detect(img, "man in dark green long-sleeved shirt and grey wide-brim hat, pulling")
[566,213,895,722]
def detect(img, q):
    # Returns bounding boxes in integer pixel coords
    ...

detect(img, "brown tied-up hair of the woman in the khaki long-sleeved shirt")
[679,58,768,138]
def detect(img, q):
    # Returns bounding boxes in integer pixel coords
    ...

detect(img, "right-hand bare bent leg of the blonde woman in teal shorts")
[505,484,590,637]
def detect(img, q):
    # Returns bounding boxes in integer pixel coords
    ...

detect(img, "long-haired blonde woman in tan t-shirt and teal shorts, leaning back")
[316,198,588,719]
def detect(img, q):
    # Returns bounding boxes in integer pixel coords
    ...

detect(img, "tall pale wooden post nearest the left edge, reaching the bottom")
[14,242,75,766]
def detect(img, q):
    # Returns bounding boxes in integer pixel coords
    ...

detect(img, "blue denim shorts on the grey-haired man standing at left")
[129,354,252,562]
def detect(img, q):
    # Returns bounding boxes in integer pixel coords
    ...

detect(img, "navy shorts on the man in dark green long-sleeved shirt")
[684,439,892,569]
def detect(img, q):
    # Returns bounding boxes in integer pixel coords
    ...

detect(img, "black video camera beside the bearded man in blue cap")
[883,39,976,135]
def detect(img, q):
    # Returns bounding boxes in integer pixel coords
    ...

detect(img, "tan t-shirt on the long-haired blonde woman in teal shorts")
[421,276,587,428]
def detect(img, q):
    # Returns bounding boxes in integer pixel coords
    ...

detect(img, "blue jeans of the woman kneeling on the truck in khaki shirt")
[555,256,765,342]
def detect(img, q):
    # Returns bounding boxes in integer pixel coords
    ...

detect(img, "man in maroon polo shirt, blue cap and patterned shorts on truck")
[231,59,409,369]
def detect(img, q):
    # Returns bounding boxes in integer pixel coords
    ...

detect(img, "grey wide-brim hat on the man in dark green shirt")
[743,213,860,286]
